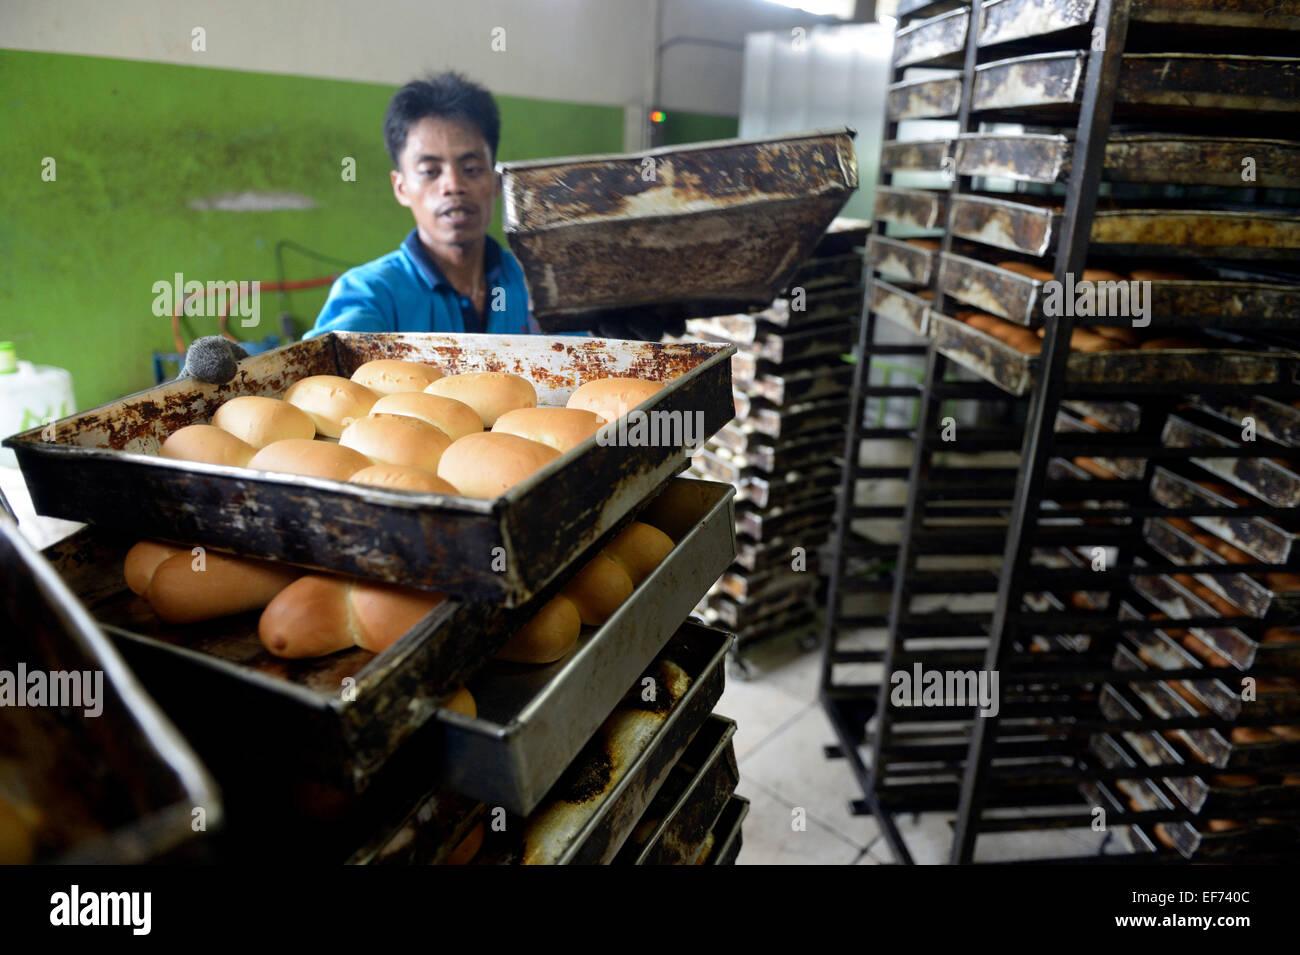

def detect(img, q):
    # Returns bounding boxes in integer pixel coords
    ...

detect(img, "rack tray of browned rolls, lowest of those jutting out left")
[930,309,1300,395]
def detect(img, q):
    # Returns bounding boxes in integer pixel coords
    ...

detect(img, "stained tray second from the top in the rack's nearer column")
[971,49,1300,121]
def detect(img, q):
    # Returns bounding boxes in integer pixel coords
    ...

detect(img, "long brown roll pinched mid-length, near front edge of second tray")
[257,574,446,660]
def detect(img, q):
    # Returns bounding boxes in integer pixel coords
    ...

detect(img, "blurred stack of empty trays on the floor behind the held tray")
[686,220,866,654]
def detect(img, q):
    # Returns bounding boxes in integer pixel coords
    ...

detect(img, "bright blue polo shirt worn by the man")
[304,229,540,338]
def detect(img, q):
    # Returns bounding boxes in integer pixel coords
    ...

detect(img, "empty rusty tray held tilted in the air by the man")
[498,127,858,331]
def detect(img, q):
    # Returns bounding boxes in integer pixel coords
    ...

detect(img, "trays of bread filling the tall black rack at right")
[832,0,1300,861]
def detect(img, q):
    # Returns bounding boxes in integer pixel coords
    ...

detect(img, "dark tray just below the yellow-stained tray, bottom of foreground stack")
[614,715,740,865]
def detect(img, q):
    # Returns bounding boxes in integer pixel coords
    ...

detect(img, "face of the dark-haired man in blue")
[393,117,498,252]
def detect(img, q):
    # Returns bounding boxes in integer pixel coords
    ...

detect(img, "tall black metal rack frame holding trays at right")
[823,0,1300,863]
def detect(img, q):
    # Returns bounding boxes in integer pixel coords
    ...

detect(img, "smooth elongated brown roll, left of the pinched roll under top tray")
[146,551,303,624]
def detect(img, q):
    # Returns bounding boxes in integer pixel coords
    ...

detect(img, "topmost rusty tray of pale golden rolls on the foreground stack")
[5,333,733,605]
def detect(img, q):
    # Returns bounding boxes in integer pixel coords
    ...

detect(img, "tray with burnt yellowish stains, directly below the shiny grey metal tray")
[481,622,732,865]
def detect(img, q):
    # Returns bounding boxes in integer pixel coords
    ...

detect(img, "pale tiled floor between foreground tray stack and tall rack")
[716,641,1114,865]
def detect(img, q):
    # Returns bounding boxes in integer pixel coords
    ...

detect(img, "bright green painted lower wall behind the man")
[0,49,623,408]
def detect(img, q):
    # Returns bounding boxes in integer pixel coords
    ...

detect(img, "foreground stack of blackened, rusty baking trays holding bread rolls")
[0,333,746,864]
